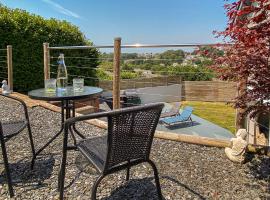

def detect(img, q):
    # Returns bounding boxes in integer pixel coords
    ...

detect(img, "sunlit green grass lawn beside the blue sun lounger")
[182,101,235,134]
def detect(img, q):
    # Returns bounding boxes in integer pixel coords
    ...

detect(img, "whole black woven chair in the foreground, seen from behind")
[59,103,163,199]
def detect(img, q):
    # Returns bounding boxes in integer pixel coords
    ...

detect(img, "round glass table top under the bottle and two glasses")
[28,86,103,101]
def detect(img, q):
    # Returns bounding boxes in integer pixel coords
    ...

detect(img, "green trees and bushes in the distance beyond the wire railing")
[100,50,214,81]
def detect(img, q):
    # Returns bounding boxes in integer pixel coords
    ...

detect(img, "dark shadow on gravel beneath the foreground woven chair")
[103,177,165,200]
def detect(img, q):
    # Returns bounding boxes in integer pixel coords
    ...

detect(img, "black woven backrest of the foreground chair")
[104,103,164,171]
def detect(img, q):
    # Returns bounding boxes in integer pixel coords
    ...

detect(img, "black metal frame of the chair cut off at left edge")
[0,94,35,197]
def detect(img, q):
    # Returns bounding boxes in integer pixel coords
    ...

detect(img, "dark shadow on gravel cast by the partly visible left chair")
[0,156,55,189]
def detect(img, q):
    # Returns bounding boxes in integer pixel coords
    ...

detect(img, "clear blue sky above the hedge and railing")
[0,0,231,52]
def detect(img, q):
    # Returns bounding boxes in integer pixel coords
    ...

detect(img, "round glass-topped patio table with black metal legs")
[28,86,103,168]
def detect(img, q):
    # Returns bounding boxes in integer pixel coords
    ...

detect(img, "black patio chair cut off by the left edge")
[0,94,35,197]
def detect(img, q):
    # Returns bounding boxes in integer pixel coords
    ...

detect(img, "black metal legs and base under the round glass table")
[31,99,85,169]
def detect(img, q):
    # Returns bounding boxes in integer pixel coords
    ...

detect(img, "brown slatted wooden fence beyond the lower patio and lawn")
[99,76,237,102]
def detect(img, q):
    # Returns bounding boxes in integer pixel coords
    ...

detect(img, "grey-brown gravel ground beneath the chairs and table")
[0,97,270,200]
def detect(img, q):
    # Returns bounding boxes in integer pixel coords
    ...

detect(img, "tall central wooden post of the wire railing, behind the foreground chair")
[113,38,121,109]
